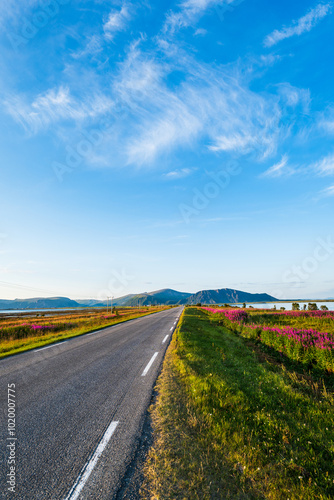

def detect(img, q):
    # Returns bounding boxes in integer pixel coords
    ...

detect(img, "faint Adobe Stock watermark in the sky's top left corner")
[7,0,71,50]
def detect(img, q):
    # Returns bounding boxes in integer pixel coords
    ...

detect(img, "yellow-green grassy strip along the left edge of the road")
[0,307,168,359]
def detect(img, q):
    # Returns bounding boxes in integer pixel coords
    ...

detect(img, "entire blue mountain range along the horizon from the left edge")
[0,288,278,309]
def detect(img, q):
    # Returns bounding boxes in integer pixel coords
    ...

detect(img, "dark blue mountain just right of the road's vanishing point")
[187,288,277,305]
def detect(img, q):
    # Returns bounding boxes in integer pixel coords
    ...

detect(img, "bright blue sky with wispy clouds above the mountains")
[0,0,334,298]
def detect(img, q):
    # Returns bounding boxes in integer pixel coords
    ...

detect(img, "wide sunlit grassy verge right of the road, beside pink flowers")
[141,308,334,500]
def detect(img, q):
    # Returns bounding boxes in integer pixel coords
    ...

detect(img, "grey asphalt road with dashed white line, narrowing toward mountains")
[0,308,182,500]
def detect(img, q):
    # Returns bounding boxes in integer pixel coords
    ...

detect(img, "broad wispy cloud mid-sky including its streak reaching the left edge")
[4,39,281,167]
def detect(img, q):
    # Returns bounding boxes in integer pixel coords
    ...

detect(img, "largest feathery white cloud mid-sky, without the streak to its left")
[108,44,280,164]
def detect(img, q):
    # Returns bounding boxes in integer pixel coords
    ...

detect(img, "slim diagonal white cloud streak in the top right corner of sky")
[264,3,332,47]
